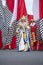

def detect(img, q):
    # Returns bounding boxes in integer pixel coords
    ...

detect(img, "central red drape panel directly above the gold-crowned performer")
[17,0,27,20]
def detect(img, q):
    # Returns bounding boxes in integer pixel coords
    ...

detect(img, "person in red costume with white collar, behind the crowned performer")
[30,19,36,50]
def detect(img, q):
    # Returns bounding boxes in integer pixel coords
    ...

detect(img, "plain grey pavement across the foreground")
[0,50,43,65]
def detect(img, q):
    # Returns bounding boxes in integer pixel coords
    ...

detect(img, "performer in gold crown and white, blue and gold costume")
[16,16,30,51]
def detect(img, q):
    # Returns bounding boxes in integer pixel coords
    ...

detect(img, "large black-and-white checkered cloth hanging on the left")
[0,0,12,45]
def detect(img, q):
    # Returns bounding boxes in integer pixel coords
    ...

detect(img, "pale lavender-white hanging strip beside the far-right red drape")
[33,0,39,20]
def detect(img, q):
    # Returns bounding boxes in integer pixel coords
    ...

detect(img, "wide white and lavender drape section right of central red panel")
[25,0,39,20]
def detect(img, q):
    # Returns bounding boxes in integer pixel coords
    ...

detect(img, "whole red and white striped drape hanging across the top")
[6,0,43,22]
